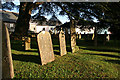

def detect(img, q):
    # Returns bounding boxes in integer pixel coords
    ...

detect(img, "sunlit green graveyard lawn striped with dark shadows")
[11,40,120,79]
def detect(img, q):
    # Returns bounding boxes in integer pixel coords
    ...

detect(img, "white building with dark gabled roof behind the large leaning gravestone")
[29,15,62,33]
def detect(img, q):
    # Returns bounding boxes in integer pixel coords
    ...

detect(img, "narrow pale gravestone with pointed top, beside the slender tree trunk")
[59,28,67,56]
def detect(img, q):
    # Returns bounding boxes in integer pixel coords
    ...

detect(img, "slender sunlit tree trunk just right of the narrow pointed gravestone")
[70,20,78,53]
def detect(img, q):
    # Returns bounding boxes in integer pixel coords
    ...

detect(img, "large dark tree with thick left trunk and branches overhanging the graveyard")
[2,2,119,42]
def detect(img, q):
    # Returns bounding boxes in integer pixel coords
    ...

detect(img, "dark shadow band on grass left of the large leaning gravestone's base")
[12,54,41,64]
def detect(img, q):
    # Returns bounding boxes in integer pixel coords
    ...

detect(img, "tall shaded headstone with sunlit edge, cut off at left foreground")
[2,25,14,79]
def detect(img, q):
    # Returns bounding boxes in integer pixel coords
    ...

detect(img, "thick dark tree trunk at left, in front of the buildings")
[15,2,32,36]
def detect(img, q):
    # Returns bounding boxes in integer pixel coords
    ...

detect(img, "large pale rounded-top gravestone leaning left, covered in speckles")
[37,31,55,65]
